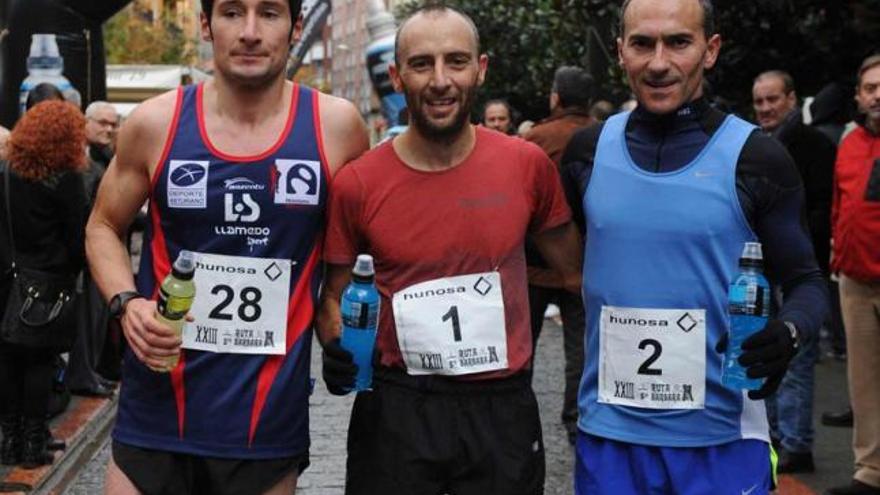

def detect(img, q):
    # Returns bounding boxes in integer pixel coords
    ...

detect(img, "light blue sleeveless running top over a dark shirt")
[578,114,768,447]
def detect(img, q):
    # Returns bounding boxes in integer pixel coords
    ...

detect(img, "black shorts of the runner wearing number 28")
[113,440,309,495]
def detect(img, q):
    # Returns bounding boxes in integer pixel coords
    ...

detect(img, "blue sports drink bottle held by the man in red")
[341,254,380,392]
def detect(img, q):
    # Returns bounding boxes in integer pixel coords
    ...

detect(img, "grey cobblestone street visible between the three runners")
[66,320,573,495]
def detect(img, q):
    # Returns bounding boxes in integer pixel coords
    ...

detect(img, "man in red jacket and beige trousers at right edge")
[828,55,880,495]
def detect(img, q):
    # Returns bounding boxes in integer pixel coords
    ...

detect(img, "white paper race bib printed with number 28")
[183,253,291,355]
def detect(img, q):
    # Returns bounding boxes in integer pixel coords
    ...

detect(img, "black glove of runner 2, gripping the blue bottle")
[739,320,797,400]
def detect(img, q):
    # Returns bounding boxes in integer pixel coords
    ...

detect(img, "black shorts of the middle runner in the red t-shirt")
[345,368,544,495]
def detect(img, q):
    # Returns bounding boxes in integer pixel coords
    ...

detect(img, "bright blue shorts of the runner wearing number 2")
[574,431,772,495]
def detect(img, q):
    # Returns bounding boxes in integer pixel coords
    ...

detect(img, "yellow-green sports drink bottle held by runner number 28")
[155,251,196,372]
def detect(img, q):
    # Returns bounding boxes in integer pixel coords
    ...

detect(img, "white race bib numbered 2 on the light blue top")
[598,306,706,409]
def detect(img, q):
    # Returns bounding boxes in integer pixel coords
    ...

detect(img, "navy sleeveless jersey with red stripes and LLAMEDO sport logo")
[113,85,329,459]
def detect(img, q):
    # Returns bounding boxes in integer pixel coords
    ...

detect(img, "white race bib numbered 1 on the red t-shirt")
[392,272,507,375]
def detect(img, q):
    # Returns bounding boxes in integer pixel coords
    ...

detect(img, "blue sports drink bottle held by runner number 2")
[721,242,770,390]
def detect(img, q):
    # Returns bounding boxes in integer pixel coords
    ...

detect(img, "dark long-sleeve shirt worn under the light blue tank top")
[561,99,828,335]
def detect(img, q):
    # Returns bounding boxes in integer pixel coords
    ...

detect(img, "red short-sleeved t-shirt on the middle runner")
[324,127,571,378]
